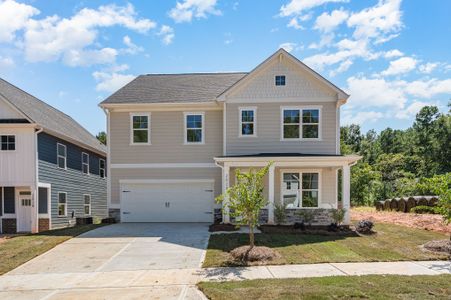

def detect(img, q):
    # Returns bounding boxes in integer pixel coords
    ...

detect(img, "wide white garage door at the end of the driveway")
[121,180,214,223]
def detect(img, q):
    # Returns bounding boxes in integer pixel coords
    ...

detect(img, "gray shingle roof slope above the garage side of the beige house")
[101,73,248,104]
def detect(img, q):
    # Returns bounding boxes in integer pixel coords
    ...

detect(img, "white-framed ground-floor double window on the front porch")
[282,172,319,208]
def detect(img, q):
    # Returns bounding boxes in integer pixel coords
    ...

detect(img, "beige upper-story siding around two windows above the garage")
[109,110,222,164]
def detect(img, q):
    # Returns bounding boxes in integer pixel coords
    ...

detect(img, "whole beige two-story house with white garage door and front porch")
[100,49,359,224]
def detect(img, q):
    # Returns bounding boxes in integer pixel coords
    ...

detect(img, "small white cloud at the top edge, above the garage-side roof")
[169,0,221,23]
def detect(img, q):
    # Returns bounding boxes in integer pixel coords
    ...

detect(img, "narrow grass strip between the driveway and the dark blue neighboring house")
[0,224,104,275]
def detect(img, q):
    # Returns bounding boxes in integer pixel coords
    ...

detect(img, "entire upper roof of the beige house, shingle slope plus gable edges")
[100,48,349,106]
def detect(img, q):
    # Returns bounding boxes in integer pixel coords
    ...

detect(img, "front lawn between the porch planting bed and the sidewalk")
[203,223,448,267]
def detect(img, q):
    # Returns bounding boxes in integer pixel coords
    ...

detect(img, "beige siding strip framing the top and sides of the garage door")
[110,167,222,205]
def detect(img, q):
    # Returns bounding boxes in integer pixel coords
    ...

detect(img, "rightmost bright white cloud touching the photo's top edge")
[347,0,402,39]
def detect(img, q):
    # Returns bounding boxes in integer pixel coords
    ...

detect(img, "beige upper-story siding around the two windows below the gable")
[226,102,337,155]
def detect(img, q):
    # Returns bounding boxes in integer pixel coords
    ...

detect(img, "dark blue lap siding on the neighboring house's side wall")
[38,133,108,229]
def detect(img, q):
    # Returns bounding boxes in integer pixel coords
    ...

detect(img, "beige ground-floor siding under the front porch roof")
[230,167,337,208]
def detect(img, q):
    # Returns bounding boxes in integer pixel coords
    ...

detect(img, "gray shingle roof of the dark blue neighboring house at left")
[0,78,106,154]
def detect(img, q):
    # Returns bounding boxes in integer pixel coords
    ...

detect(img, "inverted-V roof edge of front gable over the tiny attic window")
[217,48,349,101]
